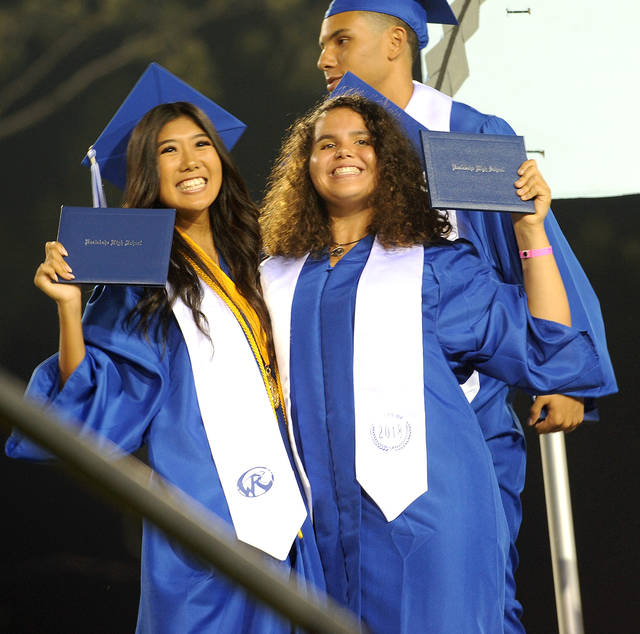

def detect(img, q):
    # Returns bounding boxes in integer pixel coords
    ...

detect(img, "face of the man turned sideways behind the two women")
[318,11,393,94]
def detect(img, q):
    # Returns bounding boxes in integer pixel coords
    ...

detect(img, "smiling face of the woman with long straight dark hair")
[157,115,222,219]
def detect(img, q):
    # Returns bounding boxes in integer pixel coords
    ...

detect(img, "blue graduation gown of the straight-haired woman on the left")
[6,286,324,634]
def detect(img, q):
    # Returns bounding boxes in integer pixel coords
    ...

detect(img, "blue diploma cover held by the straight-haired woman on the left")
[58,205,176,286]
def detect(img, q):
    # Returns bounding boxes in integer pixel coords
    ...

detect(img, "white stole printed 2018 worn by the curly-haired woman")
[261,240,427,521]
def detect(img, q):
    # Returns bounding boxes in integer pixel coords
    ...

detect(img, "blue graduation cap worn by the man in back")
[324,0,458,48]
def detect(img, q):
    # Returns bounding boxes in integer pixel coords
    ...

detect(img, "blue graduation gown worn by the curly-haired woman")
[290,237,601,634]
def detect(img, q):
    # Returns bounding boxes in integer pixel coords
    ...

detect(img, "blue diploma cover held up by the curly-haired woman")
[420,130,535,214]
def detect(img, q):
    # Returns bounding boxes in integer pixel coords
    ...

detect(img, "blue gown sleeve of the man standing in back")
[452,102,618,397]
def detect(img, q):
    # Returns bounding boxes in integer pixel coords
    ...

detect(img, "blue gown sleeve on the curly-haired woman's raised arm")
[423,240,602,394]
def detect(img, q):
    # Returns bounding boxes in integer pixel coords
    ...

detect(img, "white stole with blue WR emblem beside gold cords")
[173,281,307,560]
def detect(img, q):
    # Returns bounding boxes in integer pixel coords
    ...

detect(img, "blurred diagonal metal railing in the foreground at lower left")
[0,370,365,634]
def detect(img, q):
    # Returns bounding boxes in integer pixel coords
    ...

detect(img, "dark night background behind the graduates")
[0,0,640,634]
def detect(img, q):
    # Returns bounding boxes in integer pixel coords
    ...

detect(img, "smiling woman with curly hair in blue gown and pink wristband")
[261,95,601,634]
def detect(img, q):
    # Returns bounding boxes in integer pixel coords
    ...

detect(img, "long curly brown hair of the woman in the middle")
[260,94,451,257]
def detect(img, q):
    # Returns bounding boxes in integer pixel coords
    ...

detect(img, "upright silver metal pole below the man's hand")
[540,432,584,634]
